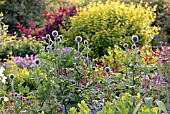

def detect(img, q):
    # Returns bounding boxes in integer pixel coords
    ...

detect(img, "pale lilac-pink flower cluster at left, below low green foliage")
[12,55,38,69]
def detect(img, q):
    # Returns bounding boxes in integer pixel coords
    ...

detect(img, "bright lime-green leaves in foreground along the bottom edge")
[69,93,167,114]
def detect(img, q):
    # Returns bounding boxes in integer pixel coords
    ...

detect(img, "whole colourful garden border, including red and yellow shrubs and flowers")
[0,0,170,114]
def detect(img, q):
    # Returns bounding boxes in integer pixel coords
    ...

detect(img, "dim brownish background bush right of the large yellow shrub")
[121,0,170,45]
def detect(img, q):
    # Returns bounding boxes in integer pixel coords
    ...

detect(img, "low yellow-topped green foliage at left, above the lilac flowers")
[0,35,43,61]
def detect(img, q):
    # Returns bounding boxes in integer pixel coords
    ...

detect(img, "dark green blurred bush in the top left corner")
[0,0,45,33]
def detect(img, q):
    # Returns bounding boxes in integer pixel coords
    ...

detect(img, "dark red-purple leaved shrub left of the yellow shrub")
[17,6,77,40]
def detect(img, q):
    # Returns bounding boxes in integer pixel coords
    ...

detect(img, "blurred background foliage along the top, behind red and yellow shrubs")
[0,0,170,45]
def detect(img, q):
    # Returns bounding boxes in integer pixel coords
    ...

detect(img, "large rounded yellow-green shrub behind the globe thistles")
[63,0,159,56]
